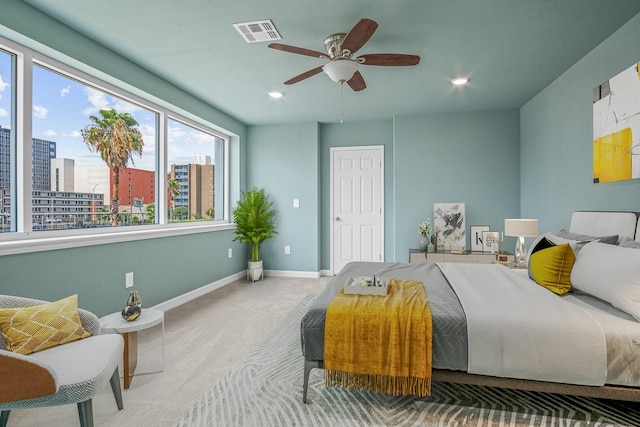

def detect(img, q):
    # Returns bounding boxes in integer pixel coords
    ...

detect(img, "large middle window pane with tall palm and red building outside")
[32,65,158,230]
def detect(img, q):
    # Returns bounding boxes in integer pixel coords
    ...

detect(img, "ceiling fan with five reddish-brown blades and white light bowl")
[269,18,420,92]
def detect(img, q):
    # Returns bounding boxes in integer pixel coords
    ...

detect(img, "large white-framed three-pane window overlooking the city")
[0,38,230,249]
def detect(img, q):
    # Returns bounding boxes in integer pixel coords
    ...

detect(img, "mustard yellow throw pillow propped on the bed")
[529,243,576,295]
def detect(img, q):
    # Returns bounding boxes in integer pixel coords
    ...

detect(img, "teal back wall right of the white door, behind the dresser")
[393,110,520,262]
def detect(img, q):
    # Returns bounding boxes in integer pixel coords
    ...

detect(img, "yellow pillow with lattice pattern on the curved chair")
[0,294,91,354]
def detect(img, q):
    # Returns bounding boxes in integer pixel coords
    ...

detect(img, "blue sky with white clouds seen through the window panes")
[0,51,214,174]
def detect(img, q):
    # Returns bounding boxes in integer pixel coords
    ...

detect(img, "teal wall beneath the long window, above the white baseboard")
[0,230,246,316]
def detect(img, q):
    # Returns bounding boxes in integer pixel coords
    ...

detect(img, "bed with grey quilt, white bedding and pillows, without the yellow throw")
[300,211,640,402]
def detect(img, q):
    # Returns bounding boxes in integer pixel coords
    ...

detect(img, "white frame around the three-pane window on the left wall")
[0,37,234,256]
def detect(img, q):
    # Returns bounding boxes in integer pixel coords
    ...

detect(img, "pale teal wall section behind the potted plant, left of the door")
[246,123,320,273]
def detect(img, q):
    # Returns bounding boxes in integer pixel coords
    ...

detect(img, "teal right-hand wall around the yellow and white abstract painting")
[520,15,640,231]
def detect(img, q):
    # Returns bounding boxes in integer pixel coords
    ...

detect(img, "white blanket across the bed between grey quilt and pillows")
[438,263,607,386]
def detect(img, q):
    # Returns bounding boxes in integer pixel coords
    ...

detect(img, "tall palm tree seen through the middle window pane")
[81,109,144,226]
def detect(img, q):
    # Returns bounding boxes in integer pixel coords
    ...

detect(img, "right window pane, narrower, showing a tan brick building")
[167,119,226,222]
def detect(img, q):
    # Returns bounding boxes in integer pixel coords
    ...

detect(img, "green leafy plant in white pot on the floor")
[232,187,278,282]
